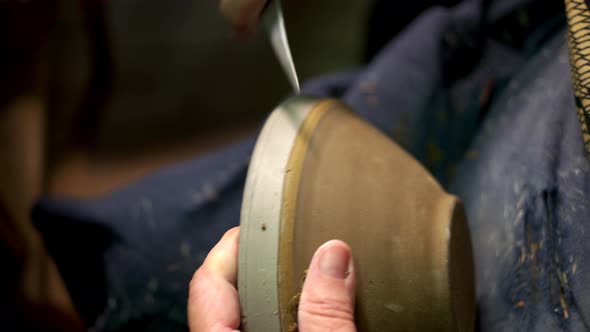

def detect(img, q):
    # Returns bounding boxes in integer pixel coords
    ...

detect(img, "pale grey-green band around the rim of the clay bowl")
[238,96,323,331]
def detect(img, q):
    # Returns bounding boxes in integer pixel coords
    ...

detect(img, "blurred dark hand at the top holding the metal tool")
[219,0,266,37]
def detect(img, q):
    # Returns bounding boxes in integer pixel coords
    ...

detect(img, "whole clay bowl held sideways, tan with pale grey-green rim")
[238,97,475,332]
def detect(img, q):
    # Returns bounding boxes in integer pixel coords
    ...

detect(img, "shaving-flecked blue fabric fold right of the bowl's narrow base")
[451,34,590,331]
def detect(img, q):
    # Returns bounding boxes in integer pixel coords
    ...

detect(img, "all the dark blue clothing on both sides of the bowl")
[34,0,590,331]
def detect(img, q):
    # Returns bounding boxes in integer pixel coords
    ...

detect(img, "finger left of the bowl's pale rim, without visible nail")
[188,227,240,332]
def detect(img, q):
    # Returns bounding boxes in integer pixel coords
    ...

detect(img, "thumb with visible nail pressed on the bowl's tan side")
[297,240,356,332]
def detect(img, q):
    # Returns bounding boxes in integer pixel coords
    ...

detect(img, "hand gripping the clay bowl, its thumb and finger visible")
[188,227,356,332]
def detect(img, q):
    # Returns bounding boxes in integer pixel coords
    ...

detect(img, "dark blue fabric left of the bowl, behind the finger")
[33,138,254,331]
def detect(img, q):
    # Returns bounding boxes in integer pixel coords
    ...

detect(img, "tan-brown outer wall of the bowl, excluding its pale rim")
[278,101,475,331]
